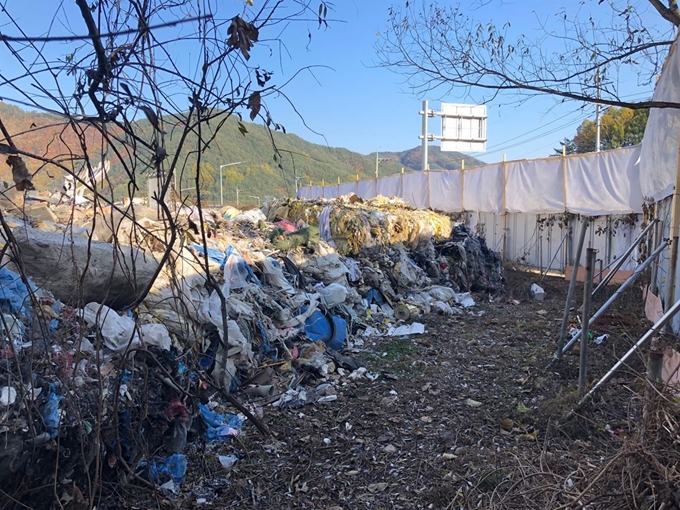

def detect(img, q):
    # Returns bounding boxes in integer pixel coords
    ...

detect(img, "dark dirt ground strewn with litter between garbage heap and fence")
[109,268,671,510]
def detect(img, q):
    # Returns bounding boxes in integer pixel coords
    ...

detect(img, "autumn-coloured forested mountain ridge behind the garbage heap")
[0,101,484,205]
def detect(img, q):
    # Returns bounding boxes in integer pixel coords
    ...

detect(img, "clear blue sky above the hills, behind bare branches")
[0,0,666,162]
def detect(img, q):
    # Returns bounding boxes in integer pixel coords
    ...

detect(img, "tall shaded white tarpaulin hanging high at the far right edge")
[640,39,680,202]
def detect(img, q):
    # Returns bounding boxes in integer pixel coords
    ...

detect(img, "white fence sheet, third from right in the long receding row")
[463,163,503,213]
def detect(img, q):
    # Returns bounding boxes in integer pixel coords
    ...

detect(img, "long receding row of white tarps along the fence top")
[298,146,644,216]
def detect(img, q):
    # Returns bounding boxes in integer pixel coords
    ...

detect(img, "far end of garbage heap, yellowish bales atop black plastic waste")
[267,194,503,293]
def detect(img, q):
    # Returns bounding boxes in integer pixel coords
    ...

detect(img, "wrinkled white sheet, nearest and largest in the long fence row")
[566,147,642,216]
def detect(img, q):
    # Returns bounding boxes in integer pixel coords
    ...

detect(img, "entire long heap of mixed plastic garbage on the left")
[0,193,502,508]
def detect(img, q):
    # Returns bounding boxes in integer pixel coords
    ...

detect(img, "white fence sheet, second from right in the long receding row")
[505,158,564,214]
